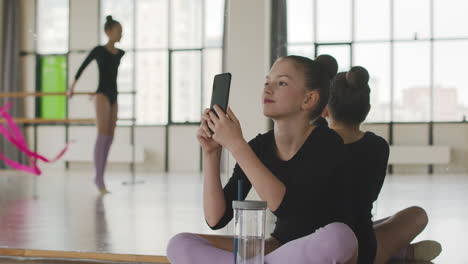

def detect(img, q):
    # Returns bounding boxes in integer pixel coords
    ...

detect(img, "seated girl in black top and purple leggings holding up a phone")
[167,55,357,264]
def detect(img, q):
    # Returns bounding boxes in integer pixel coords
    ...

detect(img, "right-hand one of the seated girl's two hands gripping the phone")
[207,105,245,152]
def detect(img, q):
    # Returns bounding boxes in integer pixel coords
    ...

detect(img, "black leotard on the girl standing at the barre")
[75,46,125,104]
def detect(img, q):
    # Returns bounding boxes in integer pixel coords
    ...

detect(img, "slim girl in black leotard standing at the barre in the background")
[67,16,125,194]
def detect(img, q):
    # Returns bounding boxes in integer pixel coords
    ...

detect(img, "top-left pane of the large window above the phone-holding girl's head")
[287,0,314,43]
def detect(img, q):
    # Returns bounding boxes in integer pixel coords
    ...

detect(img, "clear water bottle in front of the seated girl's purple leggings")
[232,201,267,264]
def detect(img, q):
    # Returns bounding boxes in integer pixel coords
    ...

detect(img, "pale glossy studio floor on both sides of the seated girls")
[0,170,468,264]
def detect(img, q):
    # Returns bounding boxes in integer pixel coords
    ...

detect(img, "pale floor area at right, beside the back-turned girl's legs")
[376,175,468,264]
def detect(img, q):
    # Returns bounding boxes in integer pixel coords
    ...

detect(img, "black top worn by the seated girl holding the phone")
[211,126,353,244]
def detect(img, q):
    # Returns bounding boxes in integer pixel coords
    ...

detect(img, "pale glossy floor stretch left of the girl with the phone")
[0,171,225,262]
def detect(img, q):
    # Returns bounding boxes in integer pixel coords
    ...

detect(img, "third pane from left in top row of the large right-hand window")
[355,0,390,40]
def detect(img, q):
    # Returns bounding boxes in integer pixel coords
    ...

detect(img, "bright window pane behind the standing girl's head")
[101,0,134,49]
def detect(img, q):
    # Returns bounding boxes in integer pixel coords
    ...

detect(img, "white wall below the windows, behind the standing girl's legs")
[35,125,200,173]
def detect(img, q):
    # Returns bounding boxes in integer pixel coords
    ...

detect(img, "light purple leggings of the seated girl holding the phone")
[167,223,358,264]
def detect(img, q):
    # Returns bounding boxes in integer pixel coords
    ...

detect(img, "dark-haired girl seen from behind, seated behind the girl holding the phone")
[322,66,441,264]
